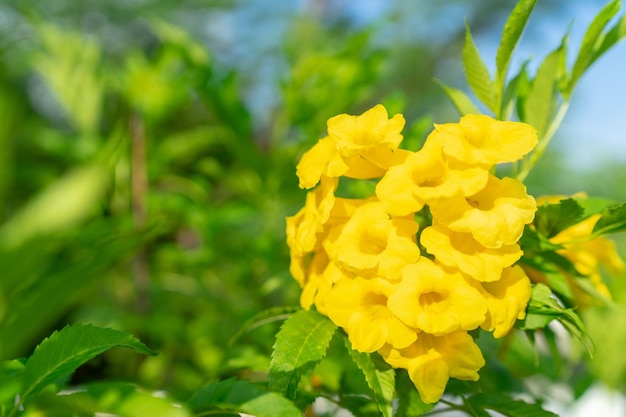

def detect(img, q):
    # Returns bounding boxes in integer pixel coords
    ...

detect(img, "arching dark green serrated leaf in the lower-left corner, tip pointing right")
[21,324,156,403]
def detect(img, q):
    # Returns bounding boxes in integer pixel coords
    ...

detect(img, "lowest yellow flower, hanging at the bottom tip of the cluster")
[379,331,485,404]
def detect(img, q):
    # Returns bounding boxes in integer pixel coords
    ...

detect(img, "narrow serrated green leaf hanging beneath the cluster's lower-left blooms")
[344,338,395,417]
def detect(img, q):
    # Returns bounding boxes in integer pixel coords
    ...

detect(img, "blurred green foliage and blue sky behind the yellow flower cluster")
[0,0,626,414]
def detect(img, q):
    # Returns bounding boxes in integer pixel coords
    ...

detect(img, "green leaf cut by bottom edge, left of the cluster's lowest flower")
[187,379,302,417]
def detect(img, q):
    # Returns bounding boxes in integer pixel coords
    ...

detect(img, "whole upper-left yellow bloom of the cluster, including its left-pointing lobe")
[296,104,407,188]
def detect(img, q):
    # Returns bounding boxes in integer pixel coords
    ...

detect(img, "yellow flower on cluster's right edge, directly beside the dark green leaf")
[430,175,537,248]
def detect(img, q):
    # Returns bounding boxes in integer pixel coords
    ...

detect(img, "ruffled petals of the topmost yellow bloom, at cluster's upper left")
[327,104,404,157]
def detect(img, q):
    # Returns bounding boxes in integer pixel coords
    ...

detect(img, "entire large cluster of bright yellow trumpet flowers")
[287,105,537,403]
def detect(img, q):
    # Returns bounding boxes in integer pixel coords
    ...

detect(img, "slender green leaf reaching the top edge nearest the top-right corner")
[564,0,623,97]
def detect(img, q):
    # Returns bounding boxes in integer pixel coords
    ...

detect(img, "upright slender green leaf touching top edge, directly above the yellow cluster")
[496,0,537,84]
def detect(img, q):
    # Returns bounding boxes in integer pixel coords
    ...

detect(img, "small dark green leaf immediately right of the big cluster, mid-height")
[534,198,585,238]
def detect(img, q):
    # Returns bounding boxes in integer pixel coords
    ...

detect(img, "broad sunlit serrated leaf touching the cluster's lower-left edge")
[268,310,336,399]
